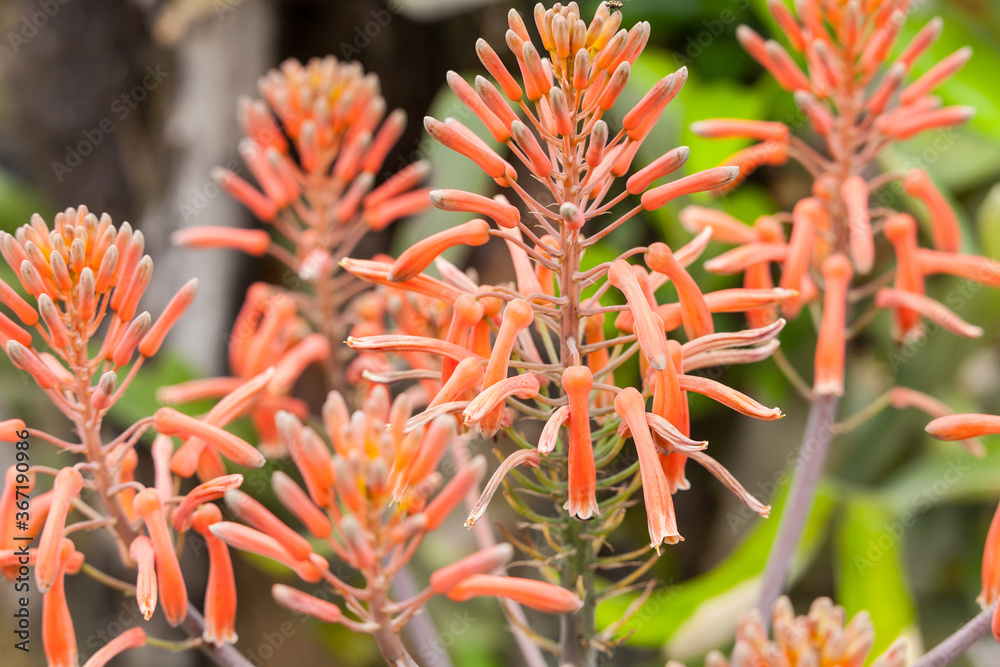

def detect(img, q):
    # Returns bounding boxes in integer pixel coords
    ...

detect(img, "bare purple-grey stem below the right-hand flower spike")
[757,394,839,627]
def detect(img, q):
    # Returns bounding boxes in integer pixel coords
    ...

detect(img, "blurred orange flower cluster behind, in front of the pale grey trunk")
[173,56,430,396]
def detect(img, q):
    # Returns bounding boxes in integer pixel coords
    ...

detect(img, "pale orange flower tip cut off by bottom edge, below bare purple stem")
[667,597,906,667]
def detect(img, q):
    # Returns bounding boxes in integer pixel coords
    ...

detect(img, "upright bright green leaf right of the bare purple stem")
[836,497,916,662]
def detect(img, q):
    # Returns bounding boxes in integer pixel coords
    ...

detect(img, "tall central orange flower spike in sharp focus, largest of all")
[342,3,794,547]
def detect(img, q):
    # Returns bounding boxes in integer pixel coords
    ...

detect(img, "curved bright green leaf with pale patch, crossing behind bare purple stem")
[597,484,834,660]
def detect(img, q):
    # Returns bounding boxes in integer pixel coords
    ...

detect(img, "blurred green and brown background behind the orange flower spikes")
[0,0,1000,667]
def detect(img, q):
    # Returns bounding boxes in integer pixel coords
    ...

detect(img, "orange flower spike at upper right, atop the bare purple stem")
[681,0,997,386]
